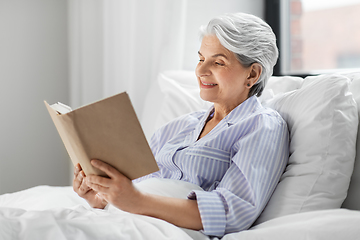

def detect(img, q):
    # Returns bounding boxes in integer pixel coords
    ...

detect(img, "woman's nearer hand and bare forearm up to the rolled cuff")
[85,160,203,230]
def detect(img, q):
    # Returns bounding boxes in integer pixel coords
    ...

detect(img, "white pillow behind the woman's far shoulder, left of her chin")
[141,71,205,140]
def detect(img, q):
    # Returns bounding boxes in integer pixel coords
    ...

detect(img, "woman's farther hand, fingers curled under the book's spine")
[73,163,107,209]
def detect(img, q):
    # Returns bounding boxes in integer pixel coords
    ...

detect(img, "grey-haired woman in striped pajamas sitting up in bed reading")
[73,13,289,236]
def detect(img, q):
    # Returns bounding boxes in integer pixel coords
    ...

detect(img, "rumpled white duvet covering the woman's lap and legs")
[0,179,209,240]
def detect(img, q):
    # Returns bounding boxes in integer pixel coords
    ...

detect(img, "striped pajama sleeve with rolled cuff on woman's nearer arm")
[188,114,289,237]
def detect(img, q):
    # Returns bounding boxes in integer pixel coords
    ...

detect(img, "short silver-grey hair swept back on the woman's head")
[200,13,279,97]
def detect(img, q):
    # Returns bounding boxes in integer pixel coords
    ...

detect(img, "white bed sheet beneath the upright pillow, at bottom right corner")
[223,209,360,240]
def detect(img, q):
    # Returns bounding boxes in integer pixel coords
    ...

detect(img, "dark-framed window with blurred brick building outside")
[266,0,360,75]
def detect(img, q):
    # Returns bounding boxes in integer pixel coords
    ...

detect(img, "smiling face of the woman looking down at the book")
[195,35,253,110]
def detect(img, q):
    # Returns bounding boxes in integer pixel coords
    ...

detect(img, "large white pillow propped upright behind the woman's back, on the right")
[256,75,358,224]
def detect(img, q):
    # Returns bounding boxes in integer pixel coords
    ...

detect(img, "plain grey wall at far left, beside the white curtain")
[0,0,70,194]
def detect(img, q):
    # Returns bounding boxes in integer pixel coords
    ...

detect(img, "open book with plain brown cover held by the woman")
[45,92,159,179]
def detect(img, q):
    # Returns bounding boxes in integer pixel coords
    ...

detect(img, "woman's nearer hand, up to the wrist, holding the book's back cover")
[85,160,143,213]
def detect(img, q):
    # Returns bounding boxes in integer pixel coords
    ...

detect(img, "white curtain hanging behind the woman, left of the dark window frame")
[68,0,263,118]
